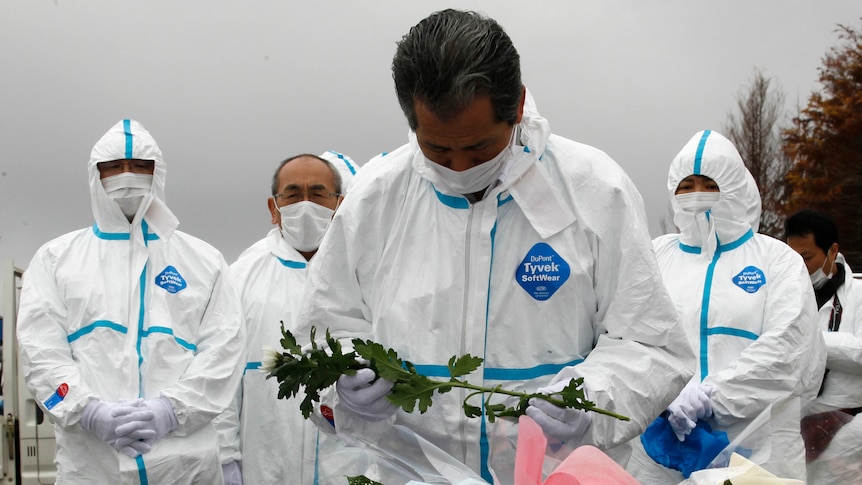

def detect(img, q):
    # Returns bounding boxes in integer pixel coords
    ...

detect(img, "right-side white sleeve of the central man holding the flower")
[552,168,695,449]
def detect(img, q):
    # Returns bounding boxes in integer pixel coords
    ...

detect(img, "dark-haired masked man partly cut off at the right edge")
[784,209,862,485]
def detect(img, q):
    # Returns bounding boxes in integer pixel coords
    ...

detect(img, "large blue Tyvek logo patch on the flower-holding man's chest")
[515,243,571,301]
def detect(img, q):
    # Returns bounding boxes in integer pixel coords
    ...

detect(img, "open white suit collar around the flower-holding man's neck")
[408,91,575,238]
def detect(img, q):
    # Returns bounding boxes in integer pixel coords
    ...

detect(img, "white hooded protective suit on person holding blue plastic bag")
[628,130,825,484]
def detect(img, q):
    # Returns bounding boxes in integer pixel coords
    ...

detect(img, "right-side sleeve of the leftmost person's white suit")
[162,258,245,436]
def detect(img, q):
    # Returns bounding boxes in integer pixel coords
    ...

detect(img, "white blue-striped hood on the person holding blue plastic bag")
[667,130,760,259]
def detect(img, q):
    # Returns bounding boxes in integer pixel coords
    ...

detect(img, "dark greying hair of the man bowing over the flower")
[392,9,523,130]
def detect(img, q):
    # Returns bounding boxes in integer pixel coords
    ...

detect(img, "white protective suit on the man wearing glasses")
[216,151,358,485]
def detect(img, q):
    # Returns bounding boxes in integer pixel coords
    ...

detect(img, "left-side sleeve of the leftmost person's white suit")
[17,243,96,426]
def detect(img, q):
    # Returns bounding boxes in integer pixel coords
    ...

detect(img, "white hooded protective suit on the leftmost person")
[18,120,243,484]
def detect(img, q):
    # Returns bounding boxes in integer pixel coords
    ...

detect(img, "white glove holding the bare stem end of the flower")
[527,380,593,444]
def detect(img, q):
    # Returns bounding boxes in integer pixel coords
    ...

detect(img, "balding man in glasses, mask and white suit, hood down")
[216,151,358,485]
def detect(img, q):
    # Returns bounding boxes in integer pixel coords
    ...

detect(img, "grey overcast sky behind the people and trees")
[0,0,862,267]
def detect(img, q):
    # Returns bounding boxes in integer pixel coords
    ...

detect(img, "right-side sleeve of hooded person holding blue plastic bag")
[703,244,826,426]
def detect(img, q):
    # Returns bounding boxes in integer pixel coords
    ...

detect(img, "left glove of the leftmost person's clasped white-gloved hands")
[81,399,154,458]
